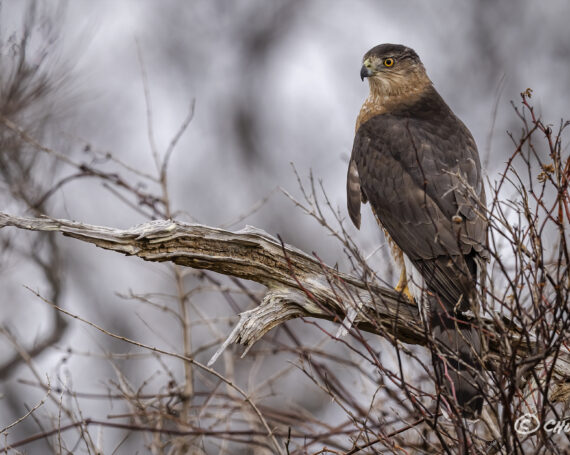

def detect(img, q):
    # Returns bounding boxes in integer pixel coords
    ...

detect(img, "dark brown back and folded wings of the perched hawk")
[348,91,486,305]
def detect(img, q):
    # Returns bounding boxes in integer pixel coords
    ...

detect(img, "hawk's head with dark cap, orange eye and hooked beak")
[360,44,431,95]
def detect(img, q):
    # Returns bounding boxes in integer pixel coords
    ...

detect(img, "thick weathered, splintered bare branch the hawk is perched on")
[0,213,418,338]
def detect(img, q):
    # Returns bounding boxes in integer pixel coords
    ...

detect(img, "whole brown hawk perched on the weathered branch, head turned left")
[347,44,487,417]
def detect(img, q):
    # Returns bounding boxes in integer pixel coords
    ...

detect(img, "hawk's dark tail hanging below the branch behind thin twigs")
[431,307,484,418]
